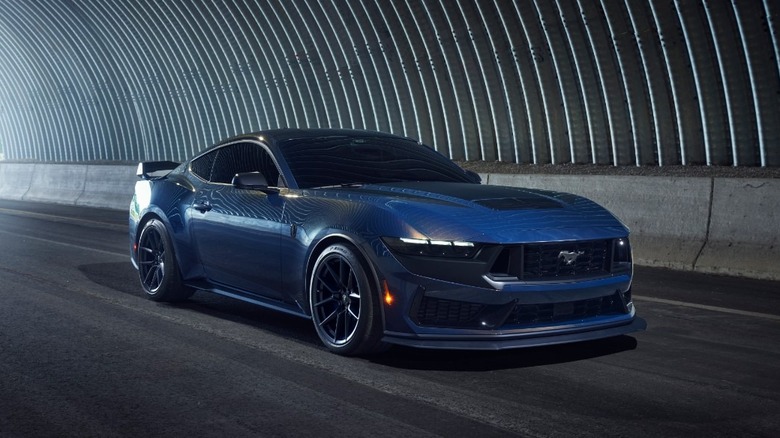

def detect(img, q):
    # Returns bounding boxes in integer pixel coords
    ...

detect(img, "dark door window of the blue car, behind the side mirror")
[211,143,279,186]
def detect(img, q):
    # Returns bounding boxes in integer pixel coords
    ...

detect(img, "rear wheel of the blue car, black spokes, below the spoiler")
[138,219,194,302]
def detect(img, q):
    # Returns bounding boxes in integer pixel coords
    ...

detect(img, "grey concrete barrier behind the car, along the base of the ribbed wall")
[0,163,780,280]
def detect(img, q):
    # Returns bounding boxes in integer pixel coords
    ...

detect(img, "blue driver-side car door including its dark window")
[189,142,284,300]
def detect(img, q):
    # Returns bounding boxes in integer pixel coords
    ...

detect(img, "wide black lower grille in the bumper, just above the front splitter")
[504,294,626,325]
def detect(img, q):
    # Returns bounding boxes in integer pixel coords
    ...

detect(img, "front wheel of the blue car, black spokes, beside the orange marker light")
[309,243,384,356]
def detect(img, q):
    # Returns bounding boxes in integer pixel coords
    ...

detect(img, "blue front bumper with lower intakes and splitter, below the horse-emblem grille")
[379,250,647,350]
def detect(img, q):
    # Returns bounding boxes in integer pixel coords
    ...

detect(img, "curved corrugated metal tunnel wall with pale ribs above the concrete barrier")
[0,0,780,166]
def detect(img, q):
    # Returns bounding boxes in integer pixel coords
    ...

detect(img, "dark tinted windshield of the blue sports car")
[280,135,474,189]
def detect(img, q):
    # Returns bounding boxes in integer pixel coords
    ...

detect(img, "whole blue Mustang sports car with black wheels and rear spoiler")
[130,129,645,355]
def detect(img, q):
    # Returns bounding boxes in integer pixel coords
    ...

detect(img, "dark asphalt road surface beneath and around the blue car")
[0,201,780,437]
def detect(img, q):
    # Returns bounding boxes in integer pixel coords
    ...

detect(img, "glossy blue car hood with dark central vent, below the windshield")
[342,182,628,243]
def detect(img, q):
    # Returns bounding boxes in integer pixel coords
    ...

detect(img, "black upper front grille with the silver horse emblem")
[490,240,612,281]
